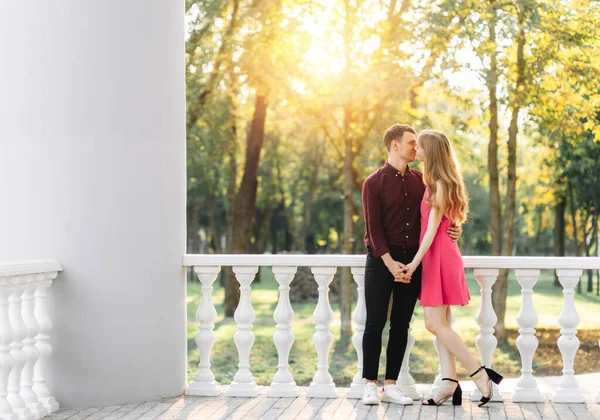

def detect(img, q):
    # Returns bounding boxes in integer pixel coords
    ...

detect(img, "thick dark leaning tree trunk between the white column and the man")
[225,92,268,317]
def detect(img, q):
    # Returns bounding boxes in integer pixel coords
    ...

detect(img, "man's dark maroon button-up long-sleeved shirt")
[362,162,425,257]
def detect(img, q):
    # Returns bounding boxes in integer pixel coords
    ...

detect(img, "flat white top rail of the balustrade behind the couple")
[183,254,600,270]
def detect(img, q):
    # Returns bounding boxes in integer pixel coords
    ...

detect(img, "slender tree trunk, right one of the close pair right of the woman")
[492,10,525,341]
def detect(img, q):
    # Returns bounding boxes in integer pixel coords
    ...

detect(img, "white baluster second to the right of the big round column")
[227,266,258,397]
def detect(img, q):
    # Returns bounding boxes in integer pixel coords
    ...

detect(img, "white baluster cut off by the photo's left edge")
[0,277,19,420]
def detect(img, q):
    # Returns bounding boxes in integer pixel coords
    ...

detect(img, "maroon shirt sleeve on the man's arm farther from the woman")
[362,178,390,257]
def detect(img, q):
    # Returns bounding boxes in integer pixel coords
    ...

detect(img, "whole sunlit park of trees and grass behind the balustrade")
[186,0,600,386]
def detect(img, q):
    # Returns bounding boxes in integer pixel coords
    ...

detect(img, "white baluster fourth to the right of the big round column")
[306,267,337,398]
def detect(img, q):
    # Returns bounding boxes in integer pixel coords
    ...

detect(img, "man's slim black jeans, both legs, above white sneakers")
[363,248,421,381]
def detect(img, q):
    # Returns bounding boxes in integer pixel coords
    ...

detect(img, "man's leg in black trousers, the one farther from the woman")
[362,256,393,382]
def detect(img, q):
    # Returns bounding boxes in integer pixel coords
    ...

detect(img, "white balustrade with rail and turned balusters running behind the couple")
[182,254,600,406]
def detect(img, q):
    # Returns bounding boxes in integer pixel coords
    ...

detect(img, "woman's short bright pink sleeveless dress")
[419,190,471,306]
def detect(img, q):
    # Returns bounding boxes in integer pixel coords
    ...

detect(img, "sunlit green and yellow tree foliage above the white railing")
[186,0,600,255]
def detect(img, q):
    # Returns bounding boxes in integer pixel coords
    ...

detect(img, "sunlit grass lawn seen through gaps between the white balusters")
[187,268,600,386]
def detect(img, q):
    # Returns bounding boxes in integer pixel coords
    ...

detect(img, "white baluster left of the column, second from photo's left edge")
[6,276,35,420]
